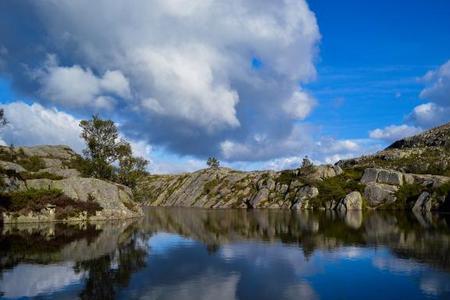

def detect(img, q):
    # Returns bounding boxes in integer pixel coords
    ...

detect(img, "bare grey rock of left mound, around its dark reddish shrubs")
[0,146,142,223]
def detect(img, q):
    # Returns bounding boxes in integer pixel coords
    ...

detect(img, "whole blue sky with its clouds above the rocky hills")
[0,0,450,173]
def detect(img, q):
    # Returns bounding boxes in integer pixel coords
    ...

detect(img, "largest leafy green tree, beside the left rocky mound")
[80,115,148,183]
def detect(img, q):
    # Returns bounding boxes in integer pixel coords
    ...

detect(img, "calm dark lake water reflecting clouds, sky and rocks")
[0,208,450,300]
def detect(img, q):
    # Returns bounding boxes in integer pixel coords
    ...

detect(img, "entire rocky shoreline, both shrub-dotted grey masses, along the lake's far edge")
[0,123,450,223]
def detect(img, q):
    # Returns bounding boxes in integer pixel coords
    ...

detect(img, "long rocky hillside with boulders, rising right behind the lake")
[140,124,450,212]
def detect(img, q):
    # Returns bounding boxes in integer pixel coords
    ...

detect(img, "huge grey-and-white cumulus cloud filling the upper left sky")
[0,0,320,160]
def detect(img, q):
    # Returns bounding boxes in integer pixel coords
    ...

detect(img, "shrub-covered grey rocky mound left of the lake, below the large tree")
[0,146,142,223]
